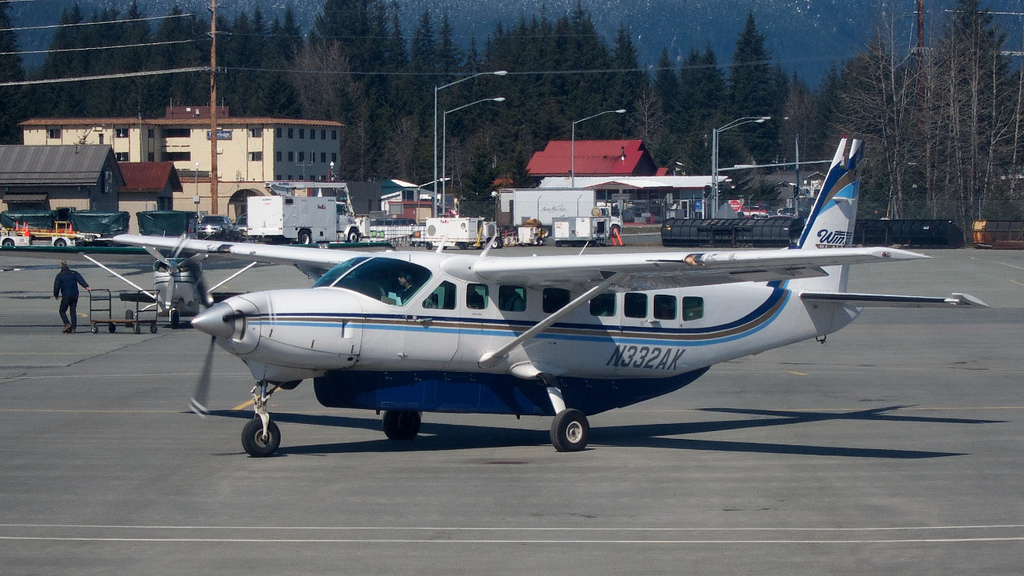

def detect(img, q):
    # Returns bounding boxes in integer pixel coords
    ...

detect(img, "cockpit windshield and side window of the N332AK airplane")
[317,253,430,306]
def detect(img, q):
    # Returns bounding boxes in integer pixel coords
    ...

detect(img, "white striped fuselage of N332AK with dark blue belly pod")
[201,254,857,414]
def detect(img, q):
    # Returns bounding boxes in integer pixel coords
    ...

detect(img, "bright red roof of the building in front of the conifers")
[526,140,658,178]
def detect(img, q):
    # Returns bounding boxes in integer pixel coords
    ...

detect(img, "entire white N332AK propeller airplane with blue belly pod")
[117,138,985,456]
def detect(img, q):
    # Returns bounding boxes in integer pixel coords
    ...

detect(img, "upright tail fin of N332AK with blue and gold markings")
[791,136,864,291]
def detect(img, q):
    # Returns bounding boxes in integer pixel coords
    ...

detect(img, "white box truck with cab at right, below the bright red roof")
[497,188,623,237]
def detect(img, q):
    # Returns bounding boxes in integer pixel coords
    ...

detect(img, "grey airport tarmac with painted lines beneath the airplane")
[0,246,1024,575]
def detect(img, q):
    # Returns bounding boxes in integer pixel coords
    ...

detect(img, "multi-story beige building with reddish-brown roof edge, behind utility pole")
[20,106,342,217]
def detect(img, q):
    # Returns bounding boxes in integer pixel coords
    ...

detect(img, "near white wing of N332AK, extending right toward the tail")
[468,248,928,290]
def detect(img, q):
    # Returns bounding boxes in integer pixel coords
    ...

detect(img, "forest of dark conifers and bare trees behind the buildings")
[0,0,1024,230]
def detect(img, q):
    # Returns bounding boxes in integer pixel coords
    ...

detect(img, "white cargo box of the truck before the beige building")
[246,196,338,244]
